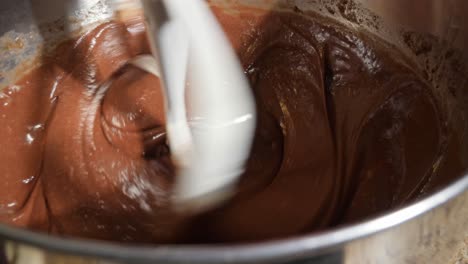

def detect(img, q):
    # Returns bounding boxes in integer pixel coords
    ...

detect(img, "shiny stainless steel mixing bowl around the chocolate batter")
[0,0,468,264]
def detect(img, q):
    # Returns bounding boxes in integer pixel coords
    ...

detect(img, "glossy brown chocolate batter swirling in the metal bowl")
[0,9,462,243]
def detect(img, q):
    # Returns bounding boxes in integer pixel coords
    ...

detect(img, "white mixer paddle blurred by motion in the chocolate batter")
[123,0,255,211]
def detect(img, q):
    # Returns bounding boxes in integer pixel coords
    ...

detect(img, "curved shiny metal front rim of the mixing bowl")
[0,175,468,263]
